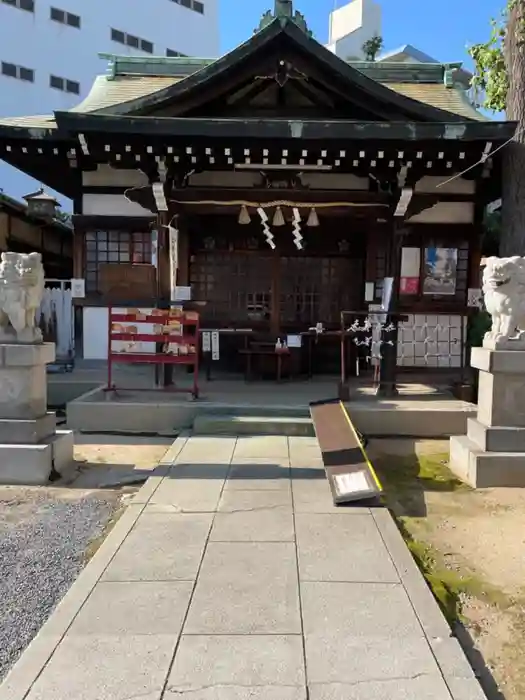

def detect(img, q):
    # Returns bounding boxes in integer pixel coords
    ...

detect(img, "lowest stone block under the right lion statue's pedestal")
[449,435,525,488]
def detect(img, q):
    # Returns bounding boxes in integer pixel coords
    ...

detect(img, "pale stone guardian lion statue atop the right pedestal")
[483,255,525,350]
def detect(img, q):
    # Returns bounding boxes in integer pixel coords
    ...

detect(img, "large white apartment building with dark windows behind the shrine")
[0,0,219,197]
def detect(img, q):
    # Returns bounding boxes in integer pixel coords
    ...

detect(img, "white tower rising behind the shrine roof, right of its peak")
[327,0,382,59]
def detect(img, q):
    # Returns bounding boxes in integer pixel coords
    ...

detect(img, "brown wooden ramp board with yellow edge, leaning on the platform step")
[310,399,383,505]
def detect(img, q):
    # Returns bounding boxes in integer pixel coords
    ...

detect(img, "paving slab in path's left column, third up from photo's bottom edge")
[102,514,212,581]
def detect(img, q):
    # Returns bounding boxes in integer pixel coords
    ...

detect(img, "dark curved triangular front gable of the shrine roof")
[88,17,470,122]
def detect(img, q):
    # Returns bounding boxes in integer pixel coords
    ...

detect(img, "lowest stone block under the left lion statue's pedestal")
[0,430,73,486]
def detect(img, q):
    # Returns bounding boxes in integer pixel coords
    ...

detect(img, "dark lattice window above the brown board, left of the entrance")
[85,231,152,292]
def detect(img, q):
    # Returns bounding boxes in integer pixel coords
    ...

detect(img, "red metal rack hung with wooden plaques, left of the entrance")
[106,306,199,398]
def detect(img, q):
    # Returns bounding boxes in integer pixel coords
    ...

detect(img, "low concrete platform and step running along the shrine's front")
[67,380,476,438]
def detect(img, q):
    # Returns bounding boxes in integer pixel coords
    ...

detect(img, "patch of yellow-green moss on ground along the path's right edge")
[374,453,510,626]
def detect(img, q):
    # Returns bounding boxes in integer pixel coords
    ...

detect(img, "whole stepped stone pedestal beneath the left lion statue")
[0,343,73,485]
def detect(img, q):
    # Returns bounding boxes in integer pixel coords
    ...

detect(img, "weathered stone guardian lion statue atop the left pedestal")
[0,253,44,343]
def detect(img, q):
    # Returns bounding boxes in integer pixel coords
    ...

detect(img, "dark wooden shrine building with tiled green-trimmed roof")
[0,0,515,382]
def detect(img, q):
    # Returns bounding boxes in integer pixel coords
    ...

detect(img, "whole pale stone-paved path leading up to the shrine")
[0,437,485,700]
